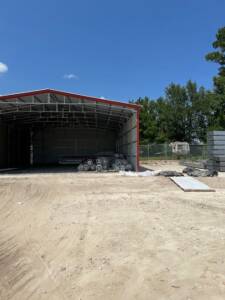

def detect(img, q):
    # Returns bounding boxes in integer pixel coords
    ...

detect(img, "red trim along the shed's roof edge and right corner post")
[0,89,141,171]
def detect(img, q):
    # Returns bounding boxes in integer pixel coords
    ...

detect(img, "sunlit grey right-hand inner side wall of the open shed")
[117,113,137,170]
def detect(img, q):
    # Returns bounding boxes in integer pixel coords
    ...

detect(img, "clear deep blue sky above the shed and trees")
[0,0,225,100]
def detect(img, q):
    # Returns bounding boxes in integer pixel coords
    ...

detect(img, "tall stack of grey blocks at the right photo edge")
[207,131,225,172]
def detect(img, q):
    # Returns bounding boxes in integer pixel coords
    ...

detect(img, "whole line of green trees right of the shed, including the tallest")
[131,27,225,143]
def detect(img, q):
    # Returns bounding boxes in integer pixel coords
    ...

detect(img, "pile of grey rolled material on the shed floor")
[77,154,132,172]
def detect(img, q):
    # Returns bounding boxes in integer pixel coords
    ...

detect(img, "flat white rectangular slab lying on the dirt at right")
[170,176,215,192]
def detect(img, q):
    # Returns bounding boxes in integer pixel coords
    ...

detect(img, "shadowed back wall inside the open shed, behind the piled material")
[33,128,116,164]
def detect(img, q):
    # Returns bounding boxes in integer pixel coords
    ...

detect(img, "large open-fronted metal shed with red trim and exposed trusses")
[0,89,140,170]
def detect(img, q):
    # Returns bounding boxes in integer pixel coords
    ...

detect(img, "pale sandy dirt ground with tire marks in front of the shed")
[0,162,225,300]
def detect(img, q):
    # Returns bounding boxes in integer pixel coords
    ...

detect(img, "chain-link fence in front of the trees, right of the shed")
[140,143,207,160]
